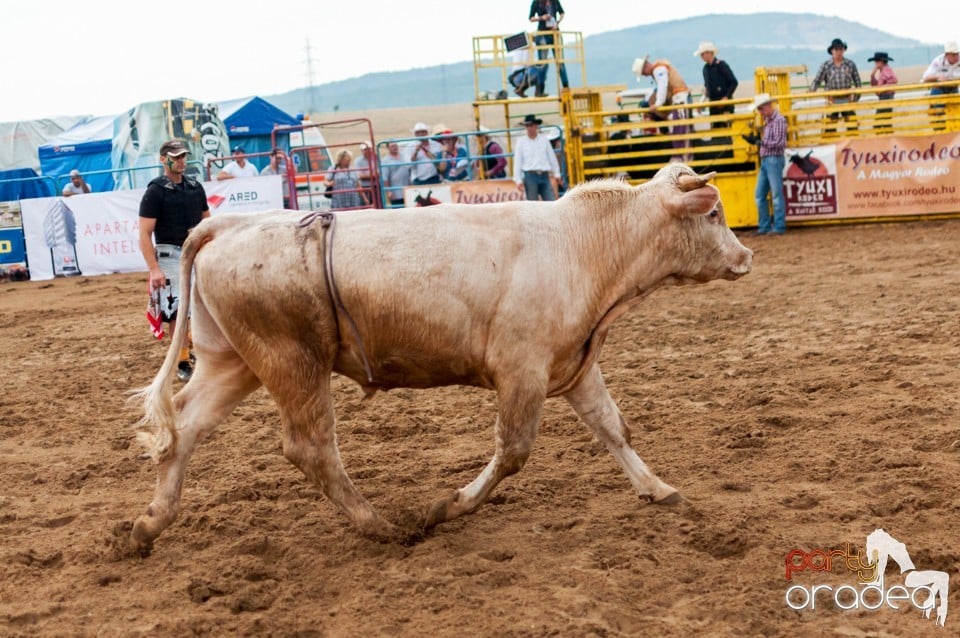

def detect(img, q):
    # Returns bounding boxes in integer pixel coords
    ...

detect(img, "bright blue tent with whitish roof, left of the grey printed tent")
[38,115,120,193]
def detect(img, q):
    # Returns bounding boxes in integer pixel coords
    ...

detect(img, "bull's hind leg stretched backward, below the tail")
[130,348,260,555]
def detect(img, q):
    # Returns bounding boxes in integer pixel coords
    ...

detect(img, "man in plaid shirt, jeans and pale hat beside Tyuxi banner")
[743,93,787,235]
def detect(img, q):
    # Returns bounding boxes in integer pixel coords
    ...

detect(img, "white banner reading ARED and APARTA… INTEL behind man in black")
[20,175,283,280]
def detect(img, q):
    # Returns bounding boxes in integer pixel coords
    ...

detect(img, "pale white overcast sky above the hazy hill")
[0,0,960,122]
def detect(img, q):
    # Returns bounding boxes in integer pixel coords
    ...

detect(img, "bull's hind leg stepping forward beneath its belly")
[272,378,399,541]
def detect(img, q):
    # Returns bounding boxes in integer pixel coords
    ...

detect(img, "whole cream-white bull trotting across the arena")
[131,164,753,554]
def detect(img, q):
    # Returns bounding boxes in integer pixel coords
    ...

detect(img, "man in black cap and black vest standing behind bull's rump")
[139,139,210,381]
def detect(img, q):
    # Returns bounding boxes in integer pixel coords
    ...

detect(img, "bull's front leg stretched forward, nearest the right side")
[563,365,682,505]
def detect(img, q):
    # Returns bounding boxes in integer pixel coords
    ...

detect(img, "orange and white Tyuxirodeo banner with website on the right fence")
[783,133,960,220]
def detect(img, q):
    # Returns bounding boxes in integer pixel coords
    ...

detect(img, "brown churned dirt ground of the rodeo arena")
[0,221,960,637]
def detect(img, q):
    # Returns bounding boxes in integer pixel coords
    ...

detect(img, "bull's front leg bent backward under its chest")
[424,374,546,530]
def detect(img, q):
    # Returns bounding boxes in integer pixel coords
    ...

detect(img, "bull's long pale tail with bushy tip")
[130,221,213,463]
